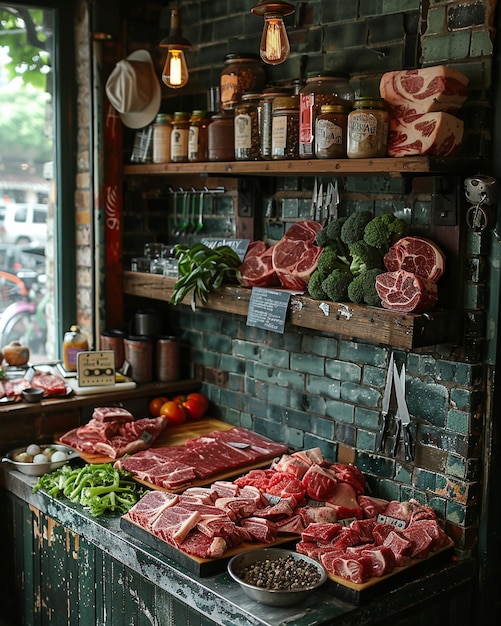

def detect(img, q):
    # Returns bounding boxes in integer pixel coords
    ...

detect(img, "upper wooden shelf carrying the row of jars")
[124,156,483,176]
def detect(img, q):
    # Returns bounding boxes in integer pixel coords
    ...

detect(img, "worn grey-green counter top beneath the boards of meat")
[0,468,475,626]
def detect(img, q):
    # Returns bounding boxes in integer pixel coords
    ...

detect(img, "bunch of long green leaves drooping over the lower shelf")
[170,243,242,310]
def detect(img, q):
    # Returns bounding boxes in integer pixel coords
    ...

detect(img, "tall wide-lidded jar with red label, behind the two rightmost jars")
[299,72,353,159]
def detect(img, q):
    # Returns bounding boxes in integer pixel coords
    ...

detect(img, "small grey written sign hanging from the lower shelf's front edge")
[247,287,291,333]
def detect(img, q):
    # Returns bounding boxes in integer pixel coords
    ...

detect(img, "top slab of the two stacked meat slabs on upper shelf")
[379,65,468,117]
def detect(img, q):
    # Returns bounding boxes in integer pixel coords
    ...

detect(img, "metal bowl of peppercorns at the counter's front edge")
[228,548,327,606]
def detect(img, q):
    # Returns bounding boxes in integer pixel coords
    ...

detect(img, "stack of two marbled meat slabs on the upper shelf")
[380,65,468,157]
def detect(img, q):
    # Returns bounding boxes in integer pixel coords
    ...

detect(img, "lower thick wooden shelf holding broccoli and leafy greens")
[124,271,461,350]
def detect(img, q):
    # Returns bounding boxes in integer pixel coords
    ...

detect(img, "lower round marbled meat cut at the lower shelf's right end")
[376,270,438,313]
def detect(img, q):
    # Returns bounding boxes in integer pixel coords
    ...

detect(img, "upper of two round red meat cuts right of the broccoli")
[384,237,445,283]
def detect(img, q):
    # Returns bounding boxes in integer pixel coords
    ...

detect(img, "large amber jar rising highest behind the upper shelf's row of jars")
[220,53,266,111]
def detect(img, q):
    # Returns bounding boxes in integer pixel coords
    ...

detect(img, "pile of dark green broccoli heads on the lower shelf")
[308,211,406,307]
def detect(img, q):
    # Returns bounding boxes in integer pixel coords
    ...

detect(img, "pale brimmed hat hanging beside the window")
[106,50,161,128]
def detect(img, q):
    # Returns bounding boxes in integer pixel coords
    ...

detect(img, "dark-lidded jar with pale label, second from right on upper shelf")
[315,104,348,159]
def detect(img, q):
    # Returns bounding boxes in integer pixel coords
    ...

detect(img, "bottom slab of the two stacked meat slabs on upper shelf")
[387,112,464,157]
